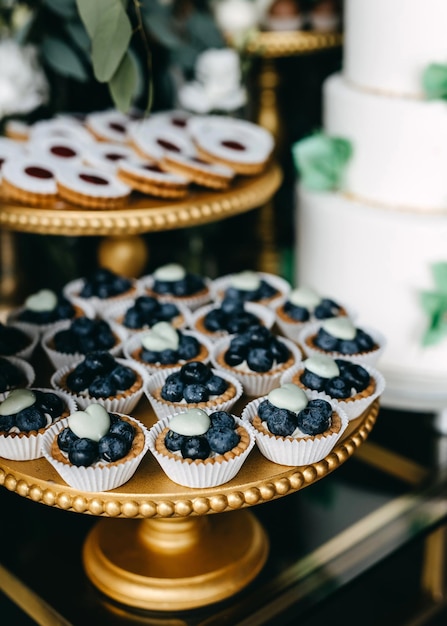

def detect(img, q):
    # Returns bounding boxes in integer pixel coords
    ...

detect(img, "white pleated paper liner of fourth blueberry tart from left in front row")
[242,392,349,467]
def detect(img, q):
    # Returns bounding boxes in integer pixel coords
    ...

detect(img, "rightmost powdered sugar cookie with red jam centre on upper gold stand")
[188,115,274,175]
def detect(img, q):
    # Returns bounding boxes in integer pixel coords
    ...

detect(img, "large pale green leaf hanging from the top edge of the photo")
[76,0,132,82]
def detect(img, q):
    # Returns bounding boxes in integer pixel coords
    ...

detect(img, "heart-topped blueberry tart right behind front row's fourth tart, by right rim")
[281,354,385,419]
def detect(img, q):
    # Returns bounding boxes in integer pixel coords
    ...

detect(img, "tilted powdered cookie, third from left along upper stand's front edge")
[117,159,189,198]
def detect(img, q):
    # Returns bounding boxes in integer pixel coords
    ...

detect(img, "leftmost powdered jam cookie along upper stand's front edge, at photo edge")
[2,156,57,206]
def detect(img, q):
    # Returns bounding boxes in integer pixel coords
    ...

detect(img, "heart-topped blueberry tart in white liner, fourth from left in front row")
[242,383,348,466]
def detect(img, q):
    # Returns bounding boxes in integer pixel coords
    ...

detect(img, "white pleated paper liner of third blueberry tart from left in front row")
[149,411,255,489]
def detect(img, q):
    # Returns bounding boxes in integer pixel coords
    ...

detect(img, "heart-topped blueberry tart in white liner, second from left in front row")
[42,403,149,492]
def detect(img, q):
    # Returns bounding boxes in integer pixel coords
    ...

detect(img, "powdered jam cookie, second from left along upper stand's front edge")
[57,165,131,209]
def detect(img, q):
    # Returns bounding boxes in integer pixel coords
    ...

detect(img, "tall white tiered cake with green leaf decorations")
[296,0,447,408]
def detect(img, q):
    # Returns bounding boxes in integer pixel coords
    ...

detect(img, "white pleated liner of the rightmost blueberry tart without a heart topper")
[211,335,301,397]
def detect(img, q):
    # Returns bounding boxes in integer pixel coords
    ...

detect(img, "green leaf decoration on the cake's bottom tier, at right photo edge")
[420,261,447,346]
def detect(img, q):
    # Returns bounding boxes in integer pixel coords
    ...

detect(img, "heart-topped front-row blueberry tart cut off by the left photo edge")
[0,387,76,461]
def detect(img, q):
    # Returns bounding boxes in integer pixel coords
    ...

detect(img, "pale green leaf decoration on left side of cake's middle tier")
[292,132,352,191]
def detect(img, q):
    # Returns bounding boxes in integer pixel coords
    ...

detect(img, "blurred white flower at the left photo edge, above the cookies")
[0,39,48,117]
